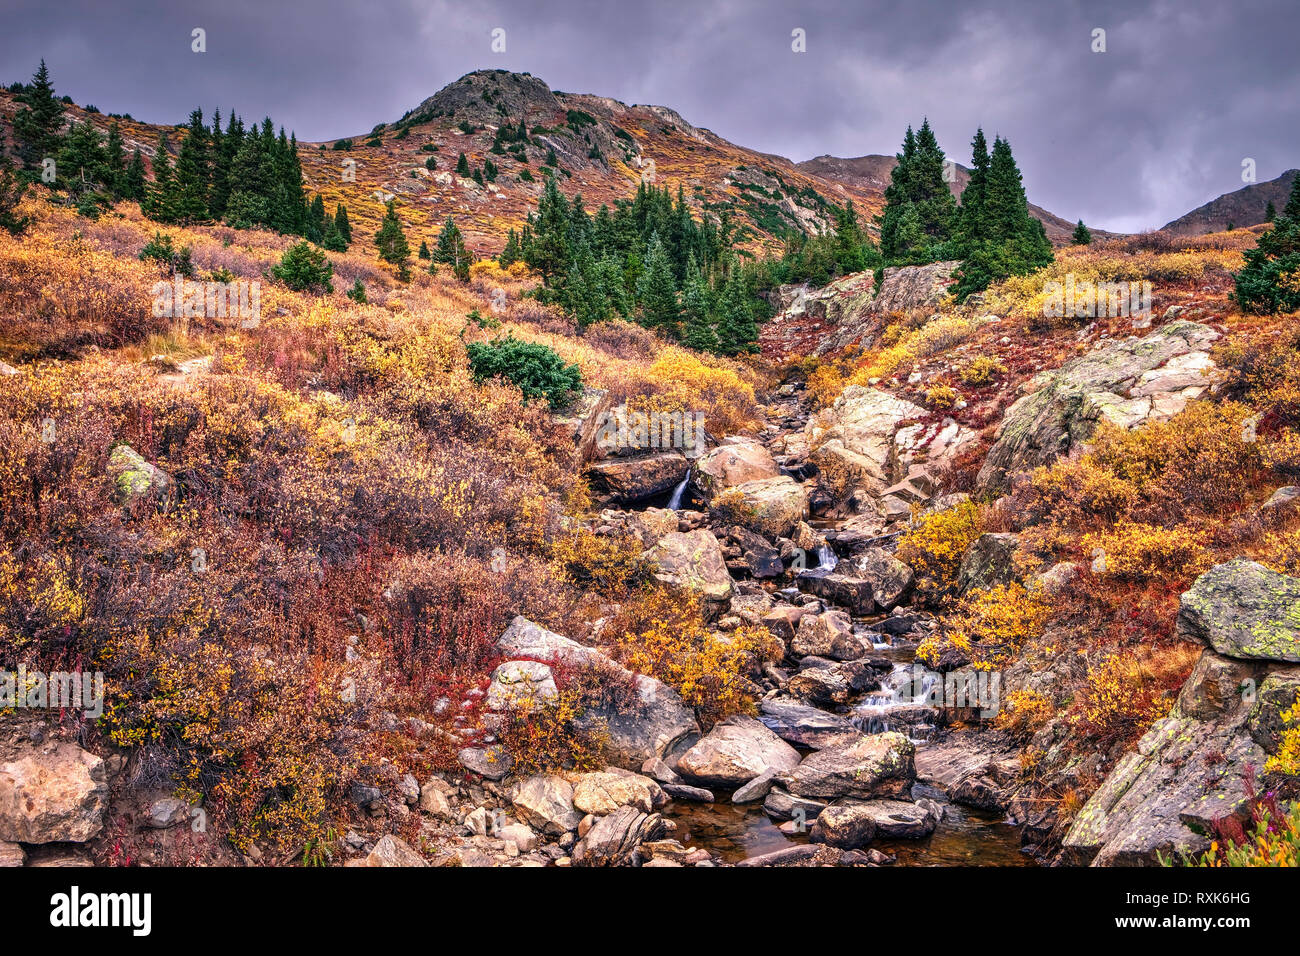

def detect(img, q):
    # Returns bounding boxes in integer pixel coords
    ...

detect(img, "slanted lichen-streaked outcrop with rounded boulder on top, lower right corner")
[1062,559,1300,866]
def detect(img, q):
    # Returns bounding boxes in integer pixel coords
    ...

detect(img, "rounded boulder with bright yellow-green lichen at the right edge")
[1177,558,1300,663]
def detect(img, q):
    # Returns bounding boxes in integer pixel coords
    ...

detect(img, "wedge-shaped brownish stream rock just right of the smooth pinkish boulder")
[777,731,917,800]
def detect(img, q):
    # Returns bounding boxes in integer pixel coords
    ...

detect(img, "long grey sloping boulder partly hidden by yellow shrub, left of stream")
[497,617,699,769]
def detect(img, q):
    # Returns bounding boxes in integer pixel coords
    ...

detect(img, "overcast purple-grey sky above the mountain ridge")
[0,0,1300,232]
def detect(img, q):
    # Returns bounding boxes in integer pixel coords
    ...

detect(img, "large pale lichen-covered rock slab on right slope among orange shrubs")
[975,321,1218,493]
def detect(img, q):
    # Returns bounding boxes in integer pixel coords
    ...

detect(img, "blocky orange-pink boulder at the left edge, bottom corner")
[0,743,108,843]
